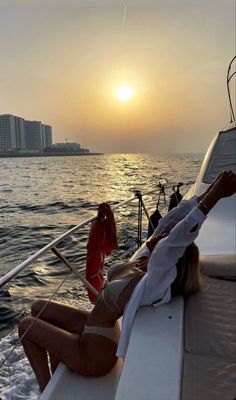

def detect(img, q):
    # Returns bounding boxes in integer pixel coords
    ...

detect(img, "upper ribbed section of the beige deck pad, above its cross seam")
[185,278,236,362]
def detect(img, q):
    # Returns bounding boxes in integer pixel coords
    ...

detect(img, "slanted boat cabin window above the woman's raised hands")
[203,129,236,183]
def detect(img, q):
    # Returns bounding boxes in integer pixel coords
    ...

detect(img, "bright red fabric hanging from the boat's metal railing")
[86,203,118,301]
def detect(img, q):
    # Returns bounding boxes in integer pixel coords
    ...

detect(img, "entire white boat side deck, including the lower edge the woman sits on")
[40,296,184,400]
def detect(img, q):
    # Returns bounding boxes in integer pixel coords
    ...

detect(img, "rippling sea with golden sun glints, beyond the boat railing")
[0,154,203,400]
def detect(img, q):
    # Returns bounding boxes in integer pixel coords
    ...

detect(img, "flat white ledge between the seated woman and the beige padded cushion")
[115,296,184,400]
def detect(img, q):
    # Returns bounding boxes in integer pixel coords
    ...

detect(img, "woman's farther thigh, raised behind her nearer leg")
[31,300,89,334]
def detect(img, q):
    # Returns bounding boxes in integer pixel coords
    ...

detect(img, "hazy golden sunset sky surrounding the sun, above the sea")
[0,0,236,153]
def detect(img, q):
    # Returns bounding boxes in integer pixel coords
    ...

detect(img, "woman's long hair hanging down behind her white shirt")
[172,242,202,296]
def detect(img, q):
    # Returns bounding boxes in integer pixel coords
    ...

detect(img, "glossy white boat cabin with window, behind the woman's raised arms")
[185,123,236,255]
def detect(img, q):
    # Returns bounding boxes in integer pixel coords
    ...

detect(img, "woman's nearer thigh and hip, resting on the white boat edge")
[19,317,117,376]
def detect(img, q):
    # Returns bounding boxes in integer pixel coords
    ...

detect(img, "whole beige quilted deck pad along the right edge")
[182,268,236,400]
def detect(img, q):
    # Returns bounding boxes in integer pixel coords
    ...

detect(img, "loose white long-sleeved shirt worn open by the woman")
[117,197,206,357]
